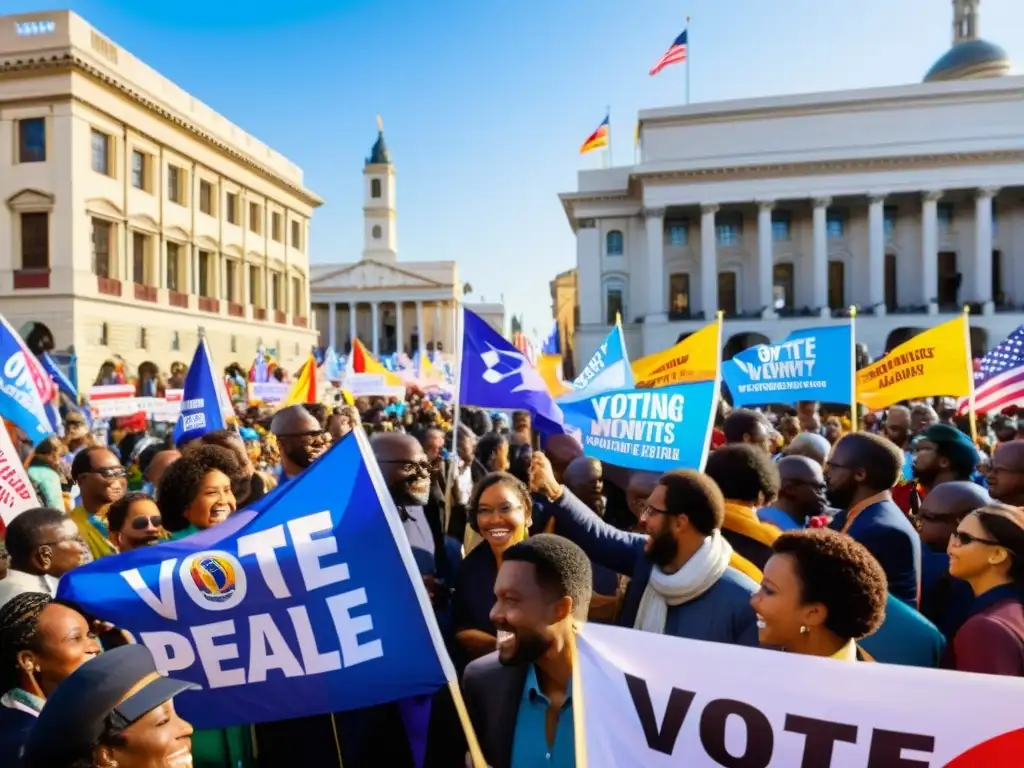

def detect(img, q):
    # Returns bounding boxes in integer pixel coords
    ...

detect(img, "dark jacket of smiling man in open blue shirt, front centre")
[462,651,529,768]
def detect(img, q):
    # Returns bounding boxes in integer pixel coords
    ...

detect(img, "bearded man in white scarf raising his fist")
[530,453,758,646]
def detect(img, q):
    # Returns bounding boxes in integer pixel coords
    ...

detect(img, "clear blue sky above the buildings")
[9,0,1024,336]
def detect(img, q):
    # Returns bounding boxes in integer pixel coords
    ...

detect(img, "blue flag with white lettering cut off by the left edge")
[0,315,55,445]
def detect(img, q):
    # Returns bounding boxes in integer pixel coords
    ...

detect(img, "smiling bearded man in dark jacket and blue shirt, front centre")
[462,534,592,768]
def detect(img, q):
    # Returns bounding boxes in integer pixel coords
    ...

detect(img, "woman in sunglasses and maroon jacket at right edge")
[944,505,1024,677]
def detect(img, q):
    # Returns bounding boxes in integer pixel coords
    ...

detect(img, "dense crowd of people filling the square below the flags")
[0,397,1024,768]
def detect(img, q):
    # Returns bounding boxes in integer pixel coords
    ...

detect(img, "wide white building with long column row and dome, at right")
[560,0,1024,360]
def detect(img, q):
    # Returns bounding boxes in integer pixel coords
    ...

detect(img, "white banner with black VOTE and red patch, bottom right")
[574,624,1024,768]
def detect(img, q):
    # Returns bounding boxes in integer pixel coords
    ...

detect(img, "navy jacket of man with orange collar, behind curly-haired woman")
[831,500,921,607]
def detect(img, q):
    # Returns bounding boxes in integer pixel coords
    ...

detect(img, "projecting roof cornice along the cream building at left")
[0,52,324,208]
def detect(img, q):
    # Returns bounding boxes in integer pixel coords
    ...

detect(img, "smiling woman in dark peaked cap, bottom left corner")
[22,645,198,768]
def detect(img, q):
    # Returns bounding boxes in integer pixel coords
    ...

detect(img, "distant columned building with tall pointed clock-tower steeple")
[310,129,505,355]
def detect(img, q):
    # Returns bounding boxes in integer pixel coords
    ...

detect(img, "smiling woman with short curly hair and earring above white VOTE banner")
[751,528,889,662]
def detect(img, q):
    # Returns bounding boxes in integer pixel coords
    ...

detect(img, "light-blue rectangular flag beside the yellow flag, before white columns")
[722,324,854,406]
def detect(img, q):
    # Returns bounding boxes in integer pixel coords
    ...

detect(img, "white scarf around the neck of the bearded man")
[633,530,732,635]
